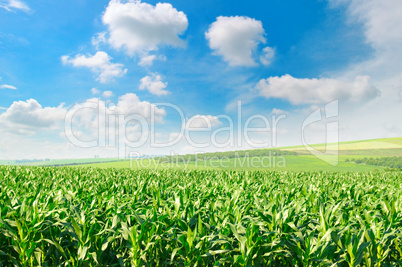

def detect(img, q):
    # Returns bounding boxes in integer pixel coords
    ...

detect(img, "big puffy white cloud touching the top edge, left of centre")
[103,0,188,55]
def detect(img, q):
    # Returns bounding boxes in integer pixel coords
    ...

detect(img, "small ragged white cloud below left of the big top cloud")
[61,51,127,83]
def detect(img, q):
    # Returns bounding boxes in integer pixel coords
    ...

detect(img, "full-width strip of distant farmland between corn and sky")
[0,138,402,172]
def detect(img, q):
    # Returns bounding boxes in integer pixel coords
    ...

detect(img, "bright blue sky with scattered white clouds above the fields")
[0,0,402,158]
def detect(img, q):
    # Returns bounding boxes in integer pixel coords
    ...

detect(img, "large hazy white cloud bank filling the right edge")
[312,0,402,140]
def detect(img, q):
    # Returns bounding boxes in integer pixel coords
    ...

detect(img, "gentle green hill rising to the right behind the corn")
[74,138,402,172]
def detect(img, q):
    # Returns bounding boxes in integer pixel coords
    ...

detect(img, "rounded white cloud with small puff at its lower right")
[205,16,274,66]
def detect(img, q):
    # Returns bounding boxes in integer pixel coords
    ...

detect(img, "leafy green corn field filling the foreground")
[0,166,402,266]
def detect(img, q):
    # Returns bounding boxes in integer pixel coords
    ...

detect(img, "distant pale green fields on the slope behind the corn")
[78,138,402,172]
